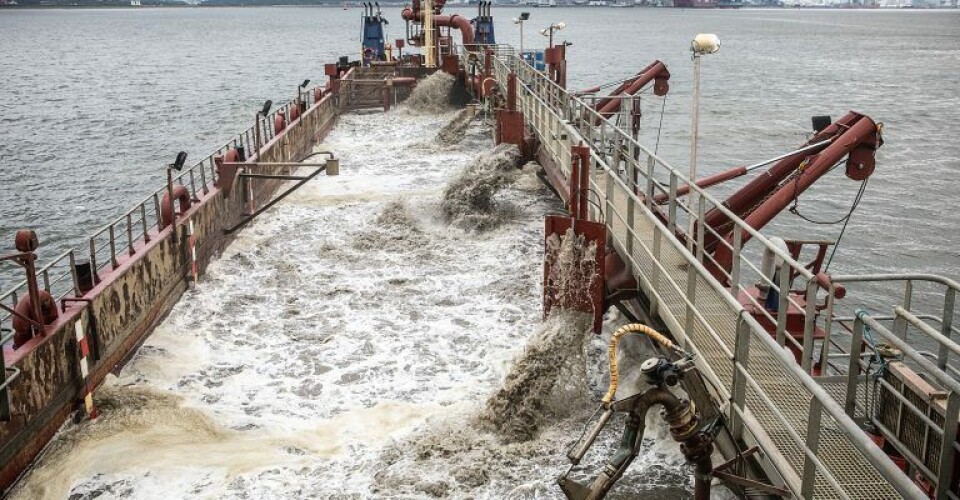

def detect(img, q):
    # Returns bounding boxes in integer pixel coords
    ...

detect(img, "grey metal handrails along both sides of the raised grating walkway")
[494,47,923,498]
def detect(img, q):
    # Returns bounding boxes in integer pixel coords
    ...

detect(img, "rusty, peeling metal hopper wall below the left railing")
[0,85,339,490]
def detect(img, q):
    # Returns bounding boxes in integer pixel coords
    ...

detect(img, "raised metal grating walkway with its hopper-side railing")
[484,46,922,500]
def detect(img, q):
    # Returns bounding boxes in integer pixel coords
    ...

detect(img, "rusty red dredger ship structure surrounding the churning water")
[0,0,960,500]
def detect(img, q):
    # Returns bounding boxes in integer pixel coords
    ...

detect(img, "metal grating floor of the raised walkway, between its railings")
[593,175,901,500]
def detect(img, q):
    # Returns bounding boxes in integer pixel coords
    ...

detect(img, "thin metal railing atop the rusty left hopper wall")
[0,83,336,348]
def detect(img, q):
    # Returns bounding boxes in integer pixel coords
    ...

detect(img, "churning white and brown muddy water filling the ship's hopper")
[7,89,712,498]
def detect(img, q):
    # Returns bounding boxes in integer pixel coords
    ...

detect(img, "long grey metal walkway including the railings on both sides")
[493,47,922,498]
